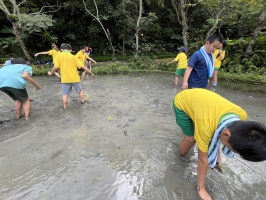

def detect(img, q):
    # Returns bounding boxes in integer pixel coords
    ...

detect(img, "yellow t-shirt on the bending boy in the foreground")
[174,88,247,152]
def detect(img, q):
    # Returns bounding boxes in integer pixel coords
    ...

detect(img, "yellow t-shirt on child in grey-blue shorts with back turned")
[54,51,84,83]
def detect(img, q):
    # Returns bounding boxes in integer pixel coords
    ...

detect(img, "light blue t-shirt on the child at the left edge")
[0,64,32,89]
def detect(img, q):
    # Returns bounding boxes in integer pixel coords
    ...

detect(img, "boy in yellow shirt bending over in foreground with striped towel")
[173,88,266,200]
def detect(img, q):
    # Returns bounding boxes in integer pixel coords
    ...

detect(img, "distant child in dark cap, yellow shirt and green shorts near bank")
[166,47,188,85]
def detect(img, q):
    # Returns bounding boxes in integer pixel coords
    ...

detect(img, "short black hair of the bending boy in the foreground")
[228,121,266,162]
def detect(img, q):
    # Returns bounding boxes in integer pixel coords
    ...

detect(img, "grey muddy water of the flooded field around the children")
[0,73,266,200]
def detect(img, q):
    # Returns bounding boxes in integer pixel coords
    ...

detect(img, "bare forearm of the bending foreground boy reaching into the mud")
[197,149,211,200]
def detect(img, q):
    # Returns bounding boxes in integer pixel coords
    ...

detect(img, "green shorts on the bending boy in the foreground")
[173,103,194,136]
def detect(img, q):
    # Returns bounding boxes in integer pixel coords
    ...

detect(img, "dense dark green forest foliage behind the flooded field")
[0,0,266,83]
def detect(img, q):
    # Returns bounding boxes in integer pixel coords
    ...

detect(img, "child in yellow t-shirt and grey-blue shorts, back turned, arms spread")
[48,43,94,109]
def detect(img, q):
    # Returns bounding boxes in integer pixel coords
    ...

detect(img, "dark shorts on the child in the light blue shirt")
[0,87,29,103]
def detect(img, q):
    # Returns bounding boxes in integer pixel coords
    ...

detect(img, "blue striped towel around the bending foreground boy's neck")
[208,114,240,168]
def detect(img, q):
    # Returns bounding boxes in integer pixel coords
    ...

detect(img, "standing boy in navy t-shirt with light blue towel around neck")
[182,33,223,90]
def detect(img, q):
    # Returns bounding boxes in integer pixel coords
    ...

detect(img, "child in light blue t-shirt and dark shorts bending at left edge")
[0,58,41,121]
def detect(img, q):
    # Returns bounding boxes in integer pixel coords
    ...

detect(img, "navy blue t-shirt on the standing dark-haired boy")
[188,50,212,88]
